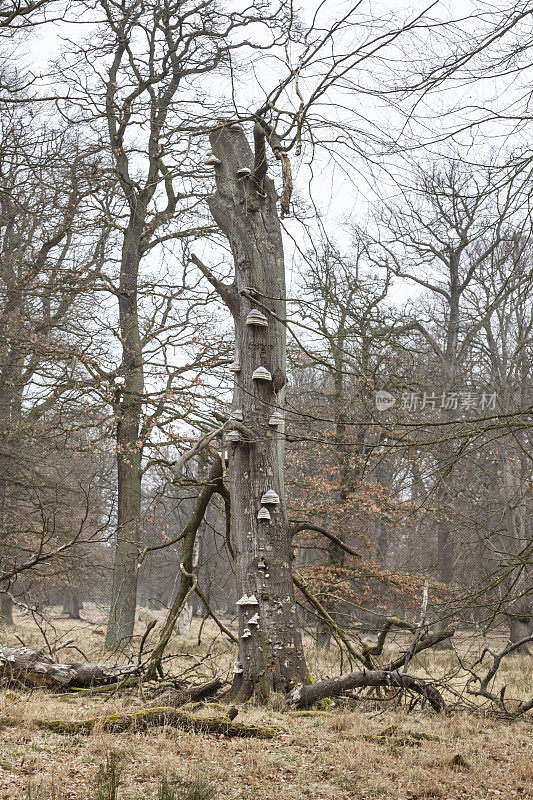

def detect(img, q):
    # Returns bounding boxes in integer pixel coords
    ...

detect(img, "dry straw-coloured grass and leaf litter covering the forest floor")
[0,608,533,800]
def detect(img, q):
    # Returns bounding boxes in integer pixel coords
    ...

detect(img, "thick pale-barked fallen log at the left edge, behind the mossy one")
[0,647,135,689]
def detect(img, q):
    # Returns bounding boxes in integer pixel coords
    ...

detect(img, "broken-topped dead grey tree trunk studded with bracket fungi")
[209,126,306,701]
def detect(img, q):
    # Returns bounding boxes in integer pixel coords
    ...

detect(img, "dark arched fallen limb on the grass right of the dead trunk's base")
[288,669,446,711]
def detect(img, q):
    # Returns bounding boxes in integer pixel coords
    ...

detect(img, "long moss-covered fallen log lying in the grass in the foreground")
[0,706,281,739]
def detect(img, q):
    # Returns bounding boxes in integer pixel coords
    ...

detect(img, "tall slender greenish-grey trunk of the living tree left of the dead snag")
[105,222,145,649]
